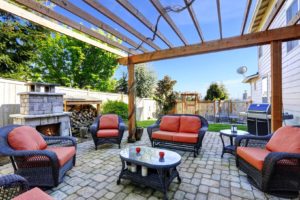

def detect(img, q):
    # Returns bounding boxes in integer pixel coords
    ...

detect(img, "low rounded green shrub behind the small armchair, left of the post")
[102,100,128,121]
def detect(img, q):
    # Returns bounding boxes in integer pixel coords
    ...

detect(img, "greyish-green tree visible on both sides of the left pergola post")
[116,64,156,98]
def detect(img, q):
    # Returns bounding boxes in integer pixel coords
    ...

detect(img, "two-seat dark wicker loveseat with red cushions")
[147,114,208,157]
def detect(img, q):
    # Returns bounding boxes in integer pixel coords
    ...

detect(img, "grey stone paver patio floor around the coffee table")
[0,132,298,200]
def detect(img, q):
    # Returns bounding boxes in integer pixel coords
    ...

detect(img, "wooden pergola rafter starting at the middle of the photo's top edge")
[150,0,188,45]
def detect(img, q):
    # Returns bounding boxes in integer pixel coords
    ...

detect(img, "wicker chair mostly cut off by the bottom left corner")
[0,174,54,200]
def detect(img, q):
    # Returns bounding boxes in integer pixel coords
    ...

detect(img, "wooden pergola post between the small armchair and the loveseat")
[128,64,136,140]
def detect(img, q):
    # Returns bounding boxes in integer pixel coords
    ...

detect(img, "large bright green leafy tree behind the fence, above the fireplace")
[33,33,117,91]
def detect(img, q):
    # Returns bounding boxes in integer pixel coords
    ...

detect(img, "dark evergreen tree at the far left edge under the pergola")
[0,11,47,80]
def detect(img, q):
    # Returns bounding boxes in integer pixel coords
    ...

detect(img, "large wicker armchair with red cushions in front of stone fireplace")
[0,125,77,187]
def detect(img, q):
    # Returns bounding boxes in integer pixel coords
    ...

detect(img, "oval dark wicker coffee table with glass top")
[117,146,181,199]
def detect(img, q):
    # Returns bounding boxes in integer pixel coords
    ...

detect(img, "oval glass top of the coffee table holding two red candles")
[120,146,181,167]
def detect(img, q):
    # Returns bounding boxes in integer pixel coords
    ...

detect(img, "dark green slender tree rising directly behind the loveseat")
[154,76,177,114]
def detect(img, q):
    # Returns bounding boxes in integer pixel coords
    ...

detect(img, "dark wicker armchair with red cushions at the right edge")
[235,126,300,198]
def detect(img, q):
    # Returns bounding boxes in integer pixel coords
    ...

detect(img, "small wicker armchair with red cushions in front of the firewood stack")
[90,114,126,150]
